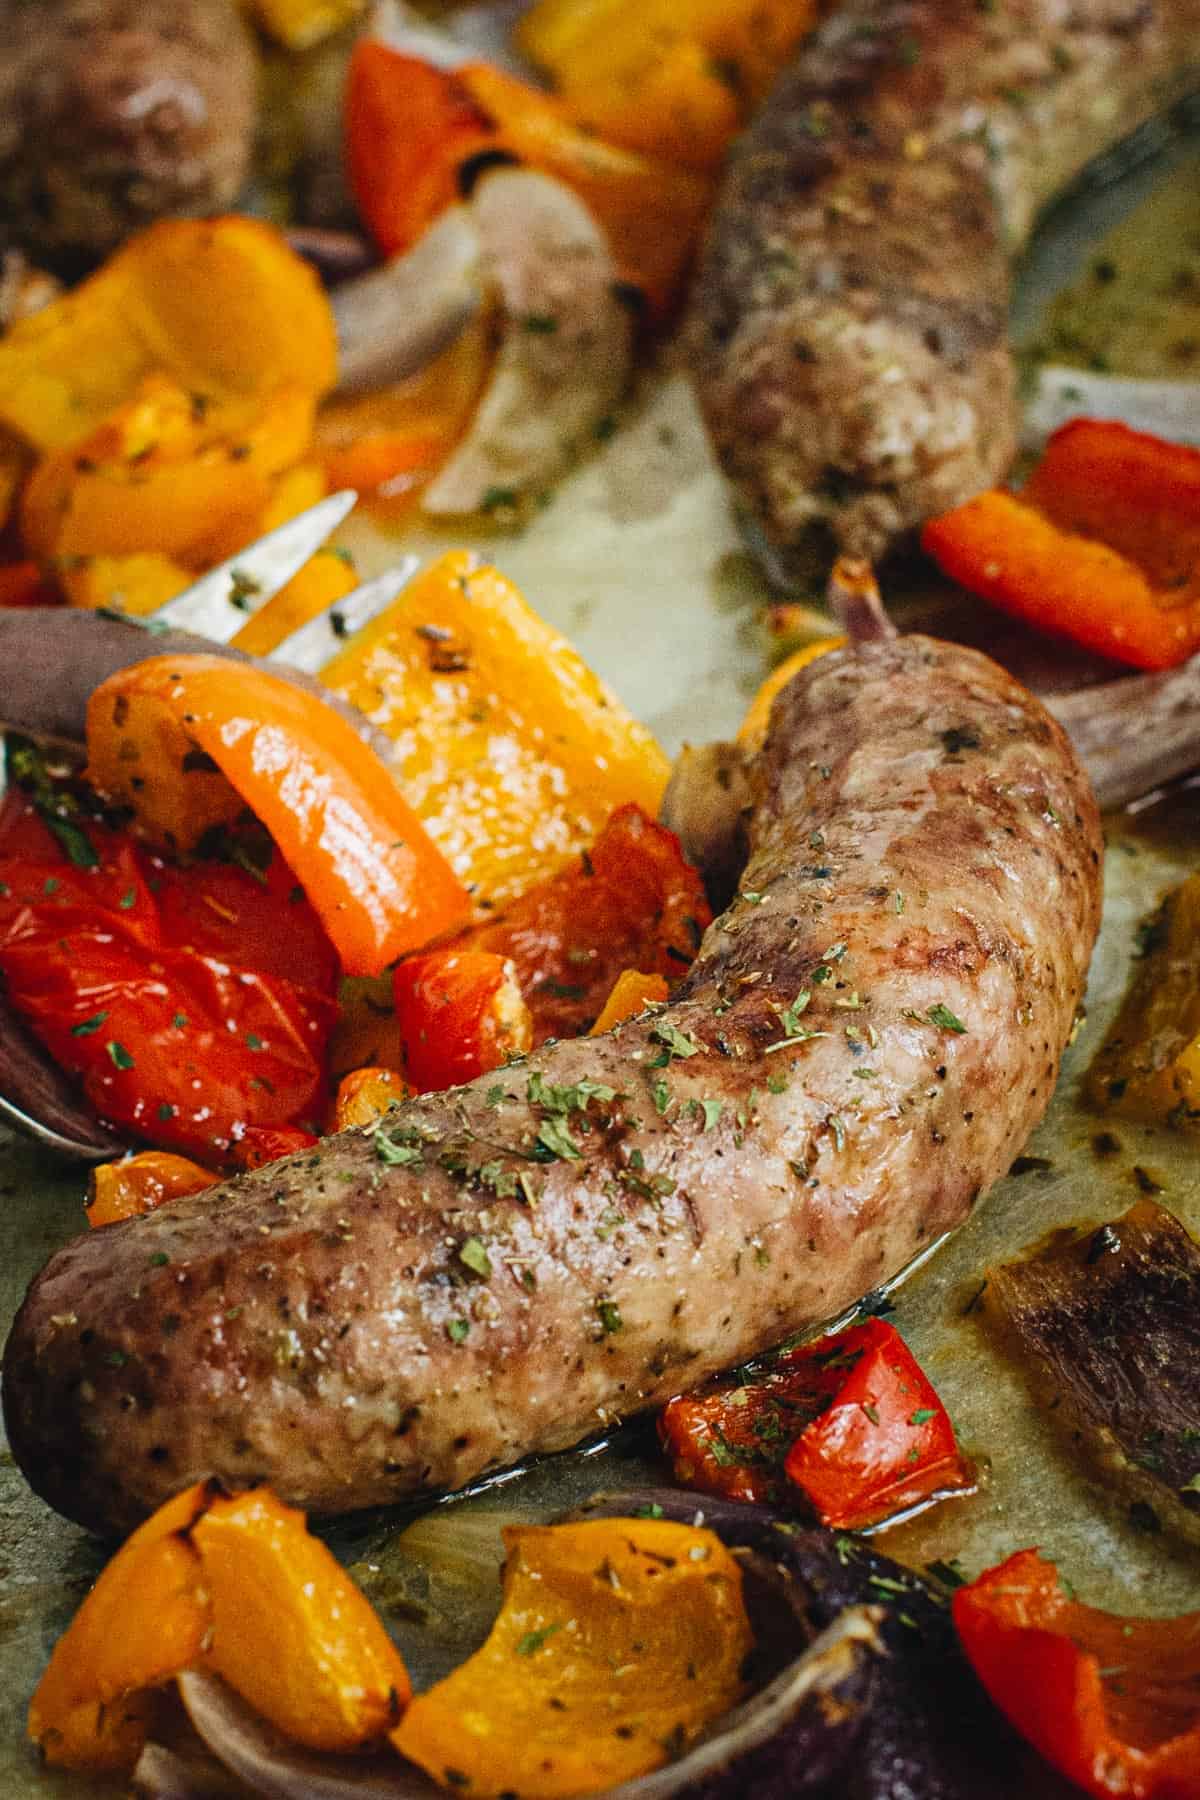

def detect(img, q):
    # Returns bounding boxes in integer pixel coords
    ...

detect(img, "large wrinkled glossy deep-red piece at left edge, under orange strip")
[0,801,336,1163]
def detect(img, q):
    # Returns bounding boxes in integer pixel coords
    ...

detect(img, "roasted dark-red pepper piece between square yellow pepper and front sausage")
[453,805,712,1046]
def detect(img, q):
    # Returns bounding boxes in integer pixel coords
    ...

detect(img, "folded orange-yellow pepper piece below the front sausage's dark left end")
[29,1481,412,1769]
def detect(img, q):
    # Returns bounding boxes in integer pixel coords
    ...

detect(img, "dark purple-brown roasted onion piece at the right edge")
[988,1201,1200,1544]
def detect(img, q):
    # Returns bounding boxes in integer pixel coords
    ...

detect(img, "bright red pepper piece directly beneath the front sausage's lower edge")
[660,1319,973,1530]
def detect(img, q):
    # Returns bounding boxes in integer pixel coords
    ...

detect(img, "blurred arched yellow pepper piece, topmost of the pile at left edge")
[0,216,336,457]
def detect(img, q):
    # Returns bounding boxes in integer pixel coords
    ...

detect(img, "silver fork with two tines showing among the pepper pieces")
[0,488,419,1163]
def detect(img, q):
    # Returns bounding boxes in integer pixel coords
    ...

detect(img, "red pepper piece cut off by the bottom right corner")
[954,1550,1200,1800]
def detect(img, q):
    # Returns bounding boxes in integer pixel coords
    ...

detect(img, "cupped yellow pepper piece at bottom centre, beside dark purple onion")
[390,1519,754,1800]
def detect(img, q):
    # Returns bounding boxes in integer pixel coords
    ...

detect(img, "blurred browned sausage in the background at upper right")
[691,0,1200,580]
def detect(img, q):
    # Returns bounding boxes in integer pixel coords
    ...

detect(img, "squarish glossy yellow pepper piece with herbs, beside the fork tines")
[322,551,669,905]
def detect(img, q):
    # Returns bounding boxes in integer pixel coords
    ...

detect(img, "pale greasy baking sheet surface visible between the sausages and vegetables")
[0,98,1200,1800]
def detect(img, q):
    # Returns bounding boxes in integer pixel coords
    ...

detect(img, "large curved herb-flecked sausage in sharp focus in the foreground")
[4,637,1101,1530]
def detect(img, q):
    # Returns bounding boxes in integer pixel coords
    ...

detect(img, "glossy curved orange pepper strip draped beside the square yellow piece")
[86,655,470,976]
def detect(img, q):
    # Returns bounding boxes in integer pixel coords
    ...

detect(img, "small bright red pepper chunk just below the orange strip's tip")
[394,949,533,1093]
